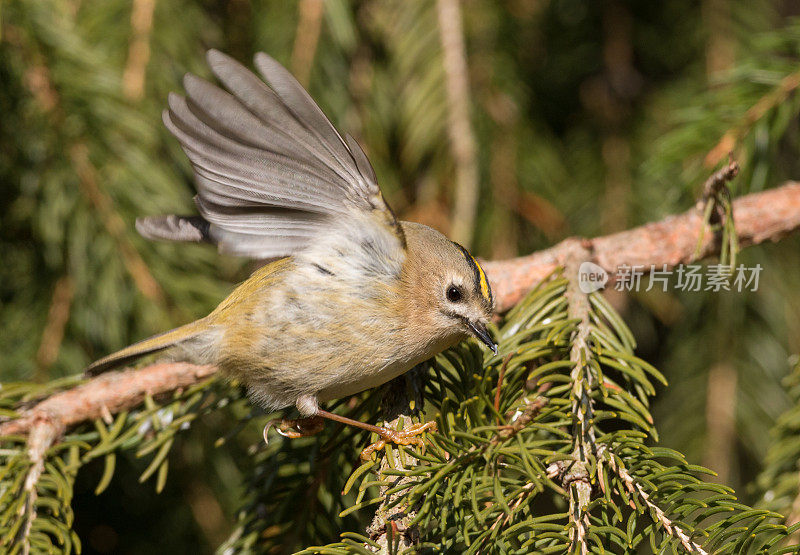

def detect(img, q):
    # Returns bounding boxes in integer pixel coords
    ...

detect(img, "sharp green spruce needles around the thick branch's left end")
[0,378,246,553]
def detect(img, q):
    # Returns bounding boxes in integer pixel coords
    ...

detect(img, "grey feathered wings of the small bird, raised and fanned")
[142,50,405,258]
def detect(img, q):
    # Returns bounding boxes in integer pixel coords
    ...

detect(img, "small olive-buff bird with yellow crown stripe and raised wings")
[87,50,497,454]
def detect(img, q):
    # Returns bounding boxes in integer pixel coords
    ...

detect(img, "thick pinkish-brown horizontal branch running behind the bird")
[0,182,800,436]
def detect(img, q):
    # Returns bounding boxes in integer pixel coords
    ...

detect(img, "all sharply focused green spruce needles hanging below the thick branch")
[0,276,796,553]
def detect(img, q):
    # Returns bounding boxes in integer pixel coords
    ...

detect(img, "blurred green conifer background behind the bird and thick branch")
[0,0,800,552]
